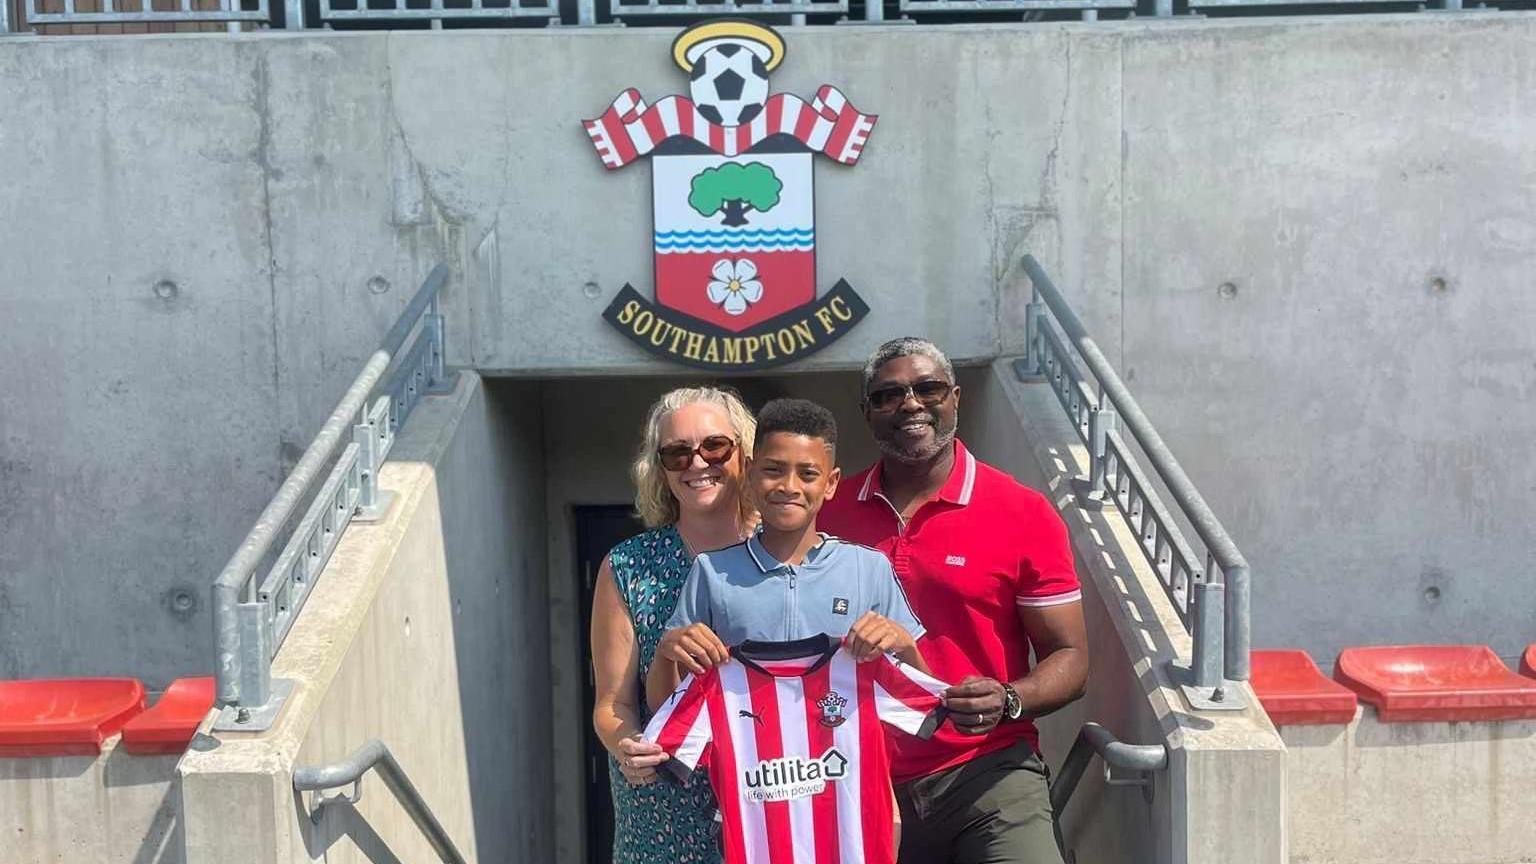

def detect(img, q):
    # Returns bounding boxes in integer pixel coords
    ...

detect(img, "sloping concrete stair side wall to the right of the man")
[960,361,1290,864]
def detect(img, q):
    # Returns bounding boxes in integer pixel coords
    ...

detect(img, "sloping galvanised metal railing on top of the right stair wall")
[1018,255,1250,710]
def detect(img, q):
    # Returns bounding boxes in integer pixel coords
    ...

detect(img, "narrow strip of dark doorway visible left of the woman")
[576,504,645,864]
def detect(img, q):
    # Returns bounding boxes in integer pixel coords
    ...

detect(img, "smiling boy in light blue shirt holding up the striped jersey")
[645,400,928,706]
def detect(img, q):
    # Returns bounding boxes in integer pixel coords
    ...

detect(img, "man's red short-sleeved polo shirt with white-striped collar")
[817,441,1083,783]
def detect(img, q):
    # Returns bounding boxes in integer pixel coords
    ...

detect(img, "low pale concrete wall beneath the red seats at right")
[1279,707,1536,864]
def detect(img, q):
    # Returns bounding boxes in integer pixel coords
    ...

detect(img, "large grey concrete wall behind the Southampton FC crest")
[0,12,1536,701]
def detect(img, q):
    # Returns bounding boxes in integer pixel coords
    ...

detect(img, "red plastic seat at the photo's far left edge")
[0,678,144,756]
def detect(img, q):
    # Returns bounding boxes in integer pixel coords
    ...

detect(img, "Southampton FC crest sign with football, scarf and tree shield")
[584,18,876,371]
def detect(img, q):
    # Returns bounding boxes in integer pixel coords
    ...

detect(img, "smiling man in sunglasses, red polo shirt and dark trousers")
[820,338,1087,864]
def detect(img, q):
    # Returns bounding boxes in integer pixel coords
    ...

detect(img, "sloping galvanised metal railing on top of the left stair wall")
[214,264,452,732]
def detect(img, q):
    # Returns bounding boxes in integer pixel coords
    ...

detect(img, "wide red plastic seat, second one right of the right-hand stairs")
[1333,646,1536,723]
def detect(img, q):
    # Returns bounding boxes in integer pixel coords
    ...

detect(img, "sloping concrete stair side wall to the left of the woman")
[180,374,553,864]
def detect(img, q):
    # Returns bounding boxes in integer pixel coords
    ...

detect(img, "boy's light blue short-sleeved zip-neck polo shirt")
[667,533,923,646]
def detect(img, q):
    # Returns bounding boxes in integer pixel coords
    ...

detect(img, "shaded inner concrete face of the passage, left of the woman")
[414,380,552,861]
